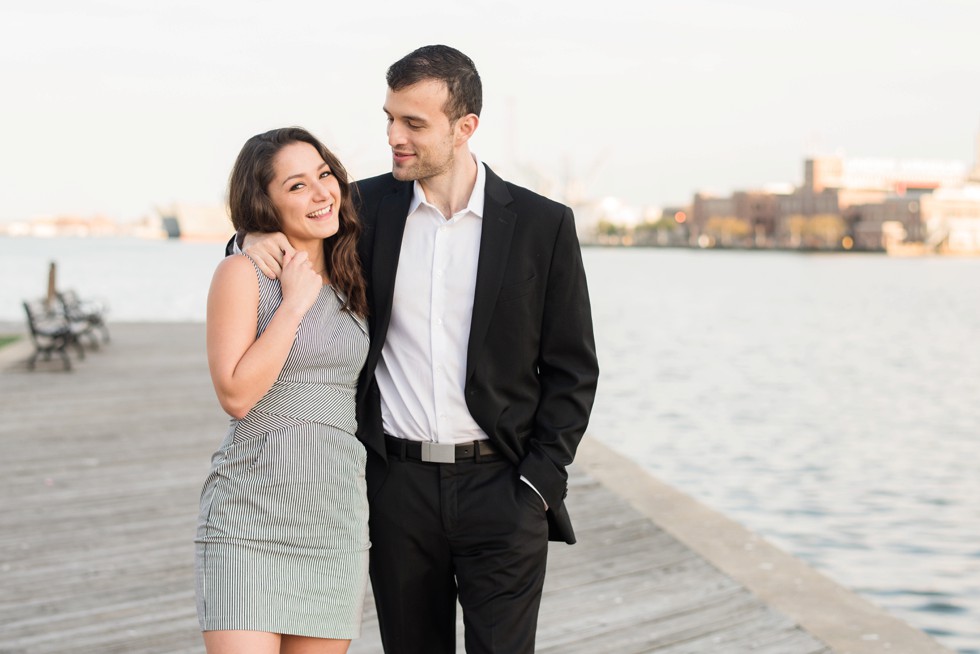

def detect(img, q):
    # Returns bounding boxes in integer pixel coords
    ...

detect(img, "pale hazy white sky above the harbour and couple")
[0,0,980,220]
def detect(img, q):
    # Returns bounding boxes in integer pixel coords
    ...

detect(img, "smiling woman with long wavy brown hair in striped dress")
[196,128,370,654]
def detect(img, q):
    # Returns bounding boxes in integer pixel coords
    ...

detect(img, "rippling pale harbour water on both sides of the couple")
[0,239,980,654]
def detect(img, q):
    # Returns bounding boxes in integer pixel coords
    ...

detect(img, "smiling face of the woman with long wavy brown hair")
[267,142,340,245]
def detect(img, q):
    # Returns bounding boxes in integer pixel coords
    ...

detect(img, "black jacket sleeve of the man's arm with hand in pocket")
[520,207,599,507]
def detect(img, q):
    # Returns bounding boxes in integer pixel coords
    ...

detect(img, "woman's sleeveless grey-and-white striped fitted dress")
[195,258,370,639]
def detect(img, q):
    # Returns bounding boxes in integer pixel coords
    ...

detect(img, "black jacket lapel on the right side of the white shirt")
[466,166,517,382]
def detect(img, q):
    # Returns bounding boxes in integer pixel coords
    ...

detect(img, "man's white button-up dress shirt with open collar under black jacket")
[376,157,487,443]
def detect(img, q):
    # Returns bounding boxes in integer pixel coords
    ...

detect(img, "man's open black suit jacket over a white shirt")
[355,168,599,543]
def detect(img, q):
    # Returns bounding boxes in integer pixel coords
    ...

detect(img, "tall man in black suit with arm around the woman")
[242,45,598,654]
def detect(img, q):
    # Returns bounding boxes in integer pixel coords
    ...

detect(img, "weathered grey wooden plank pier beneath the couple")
[0,323,948,654]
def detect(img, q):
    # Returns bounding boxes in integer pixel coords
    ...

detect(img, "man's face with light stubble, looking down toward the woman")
[384,80,459,181]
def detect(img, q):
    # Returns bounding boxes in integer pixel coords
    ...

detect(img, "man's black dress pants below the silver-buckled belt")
[370,455,548,654]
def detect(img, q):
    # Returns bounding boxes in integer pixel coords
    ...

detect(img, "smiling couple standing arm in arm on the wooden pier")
[197,45,598,654]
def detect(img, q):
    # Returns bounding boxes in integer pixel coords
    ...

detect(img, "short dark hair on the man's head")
[386,45,483,122]
